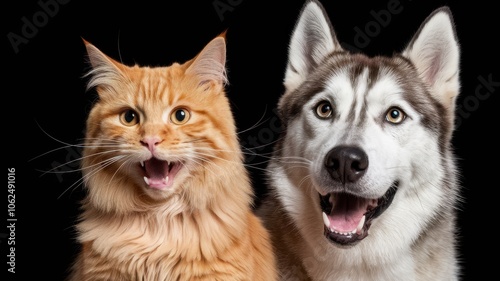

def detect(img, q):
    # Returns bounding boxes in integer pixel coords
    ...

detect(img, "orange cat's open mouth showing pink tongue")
[140,157,182,189]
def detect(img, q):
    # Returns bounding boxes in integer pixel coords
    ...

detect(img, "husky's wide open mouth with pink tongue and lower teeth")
[320,182,398,246]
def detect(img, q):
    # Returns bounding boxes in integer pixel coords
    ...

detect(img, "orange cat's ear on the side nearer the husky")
[186,33,227,86]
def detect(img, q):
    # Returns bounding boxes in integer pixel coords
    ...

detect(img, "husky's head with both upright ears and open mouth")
[277,1,459,246]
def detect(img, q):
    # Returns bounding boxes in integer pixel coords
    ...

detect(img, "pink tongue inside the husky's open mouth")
[329,194,368,232]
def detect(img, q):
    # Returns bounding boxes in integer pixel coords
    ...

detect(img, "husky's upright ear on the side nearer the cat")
[284,0,341,92]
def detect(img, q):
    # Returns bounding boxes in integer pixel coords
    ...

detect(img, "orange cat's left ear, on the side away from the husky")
[82,38,125,93]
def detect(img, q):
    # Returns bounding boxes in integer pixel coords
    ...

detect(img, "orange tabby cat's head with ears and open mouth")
[82,37,240,209]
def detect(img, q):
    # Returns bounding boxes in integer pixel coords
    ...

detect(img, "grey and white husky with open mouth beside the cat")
[258,0,461,281]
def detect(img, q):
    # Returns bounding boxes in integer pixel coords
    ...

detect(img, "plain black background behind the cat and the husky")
[0,0,500,280]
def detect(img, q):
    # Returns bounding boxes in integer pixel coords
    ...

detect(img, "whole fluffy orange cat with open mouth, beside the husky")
[70,34,277,281]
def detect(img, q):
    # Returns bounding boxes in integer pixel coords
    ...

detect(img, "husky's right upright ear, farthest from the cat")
[403,6,460,118]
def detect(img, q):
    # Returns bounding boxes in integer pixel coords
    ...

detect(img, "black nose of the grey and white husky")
[325,146,368,183]
